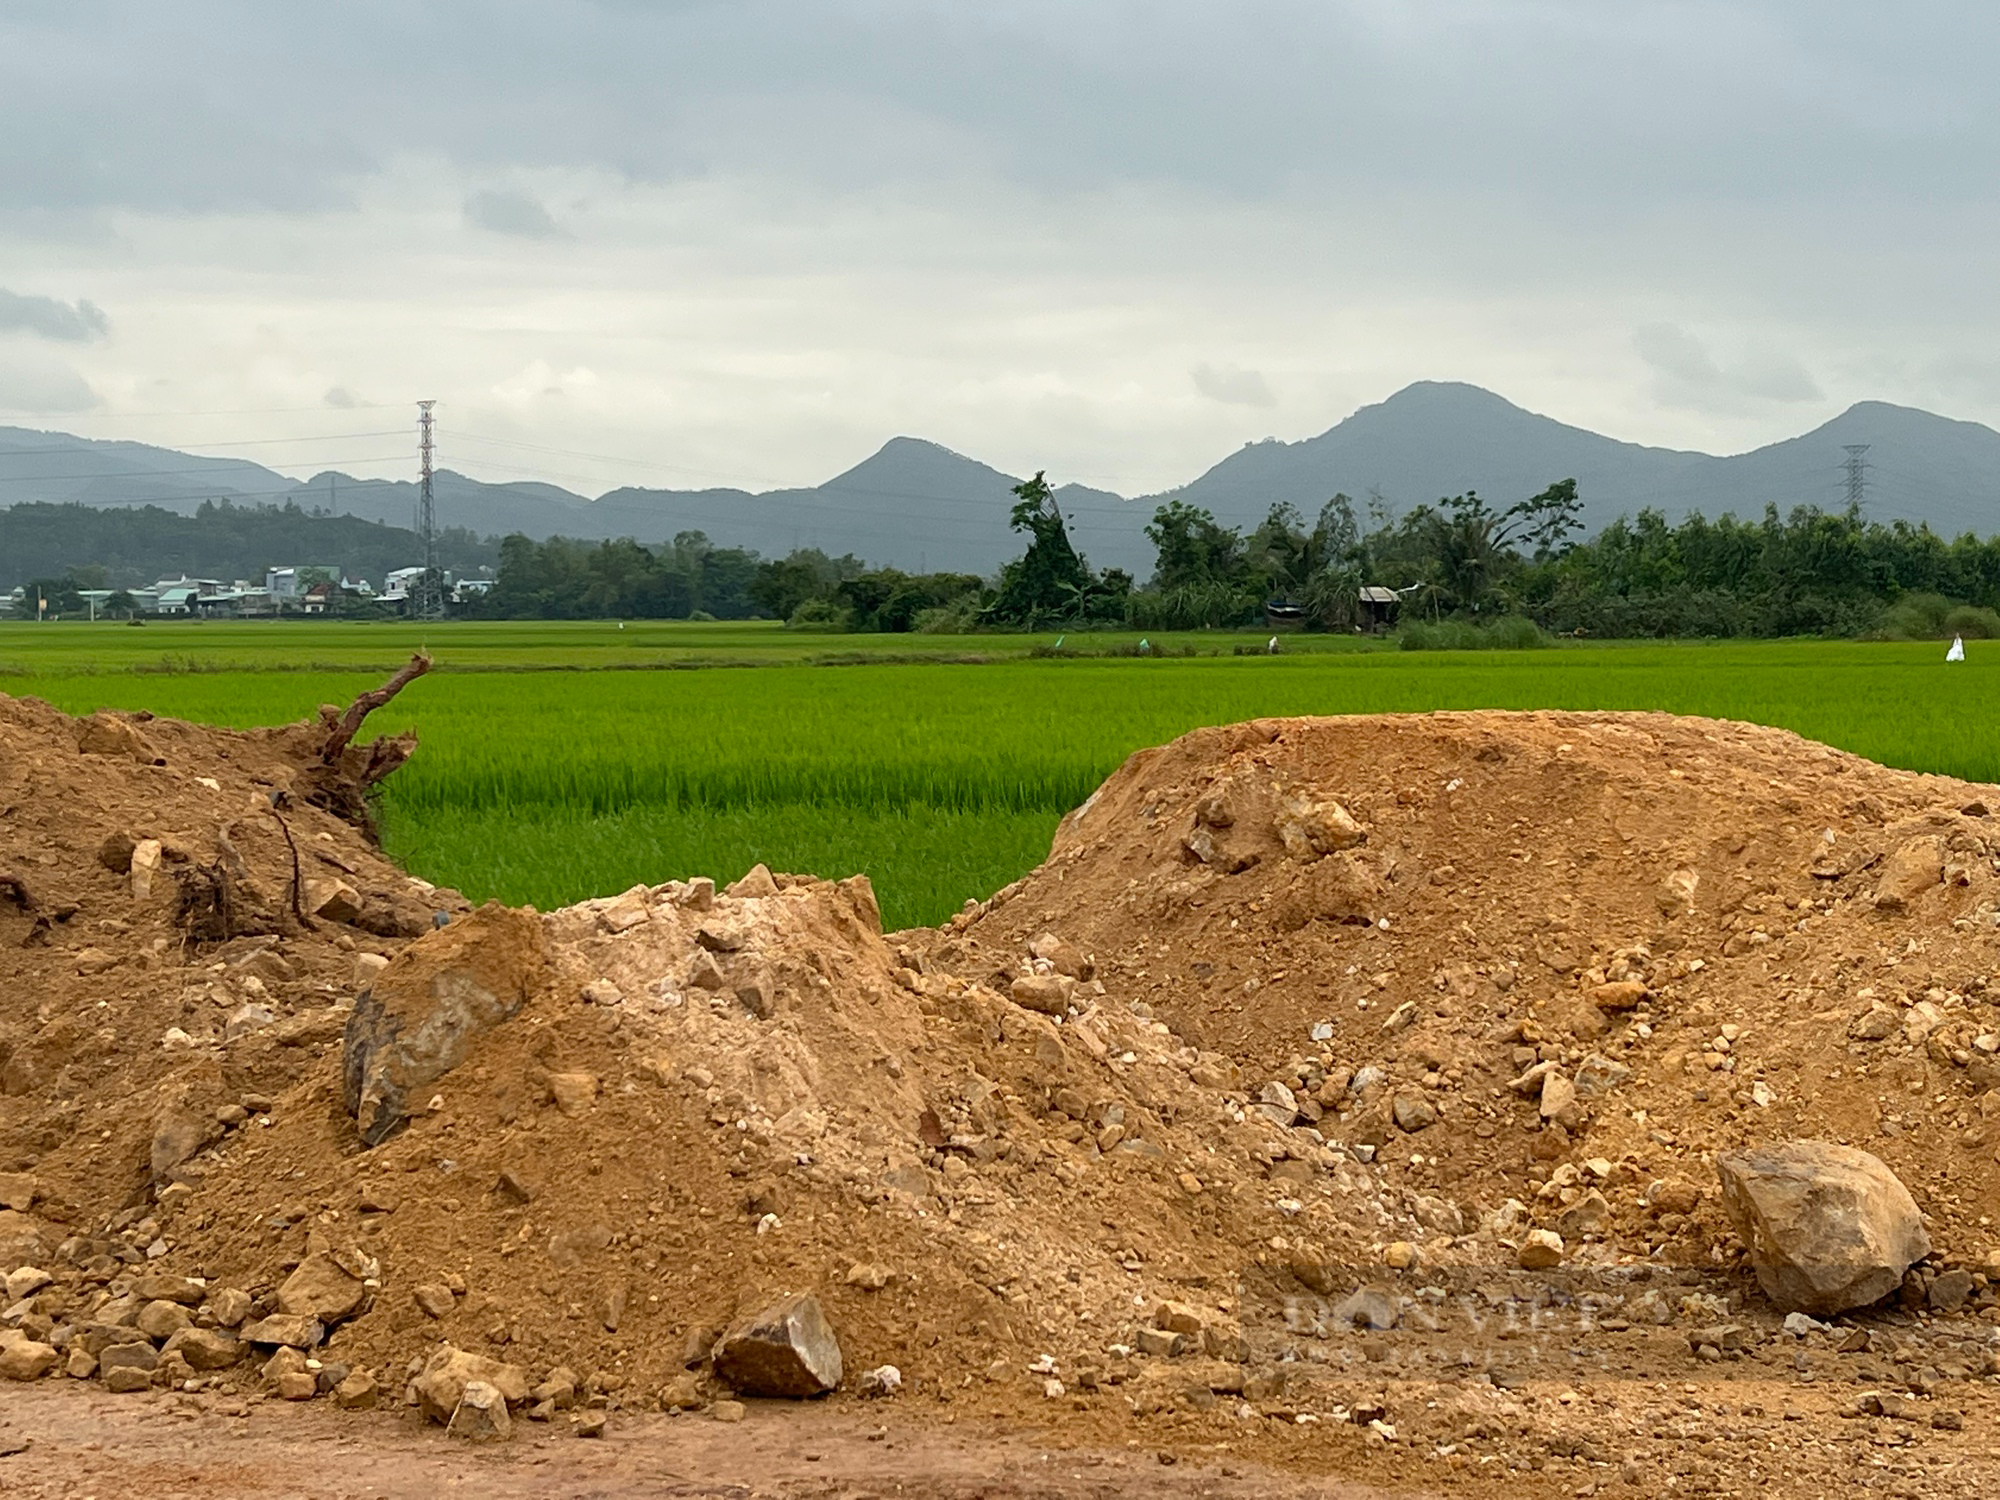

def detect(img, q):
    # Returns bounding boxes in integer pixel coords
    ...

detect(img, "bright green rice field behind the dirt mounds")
[0,622,2000,926]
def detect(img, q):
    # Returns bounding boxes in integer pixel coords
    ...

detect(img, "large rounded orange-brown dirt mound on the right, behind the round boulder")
[934,714,2000,1272]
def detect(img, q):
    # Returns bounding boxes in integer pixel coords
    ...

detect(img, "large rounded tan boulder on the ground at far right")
[1716,1140,1930,1318]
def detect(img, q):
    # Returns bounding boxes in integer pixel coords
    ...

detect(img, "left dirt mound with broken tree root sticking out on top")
[0,696,452,1216]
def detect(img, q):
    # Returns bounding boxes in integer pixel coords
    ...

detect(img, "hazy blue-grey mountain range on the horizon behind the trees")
[0,382,2000,576]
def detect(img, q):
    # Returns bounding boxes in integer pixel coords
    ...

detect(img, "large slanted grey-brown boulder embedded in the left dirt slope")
[342,904,548,1146]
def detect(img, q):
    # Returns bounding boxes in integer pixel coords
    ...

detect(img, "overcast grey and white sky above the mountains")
[0,0,2000,494]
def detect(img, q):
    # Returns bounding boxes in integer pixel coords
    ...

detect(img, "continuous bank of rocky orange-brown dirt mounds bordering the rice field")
[11,698,2000,1492]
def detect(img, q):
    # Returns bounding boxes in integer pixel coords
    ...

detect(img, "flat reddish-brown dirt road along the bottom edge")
[0,1384,1412,1500]
